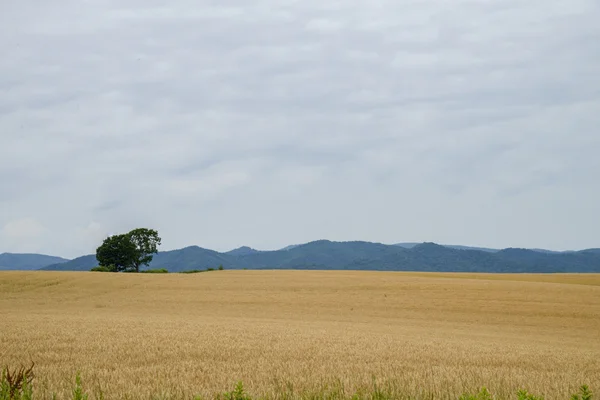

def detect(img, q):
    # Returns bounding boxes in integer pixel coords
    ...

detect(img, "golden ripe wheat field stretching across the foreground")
[0,271,600,399]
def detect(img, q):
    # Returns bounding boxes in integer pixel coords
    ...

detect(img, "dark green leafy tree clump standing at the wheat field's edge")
[96,228,161,272]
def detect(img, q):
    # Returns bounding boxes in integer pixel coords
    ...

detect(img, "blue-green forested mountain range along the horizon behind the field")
[0,240,600,273]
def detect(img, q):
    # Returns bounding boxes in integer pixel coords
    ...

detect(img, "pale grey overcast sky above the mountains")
[0,0,600,257]
